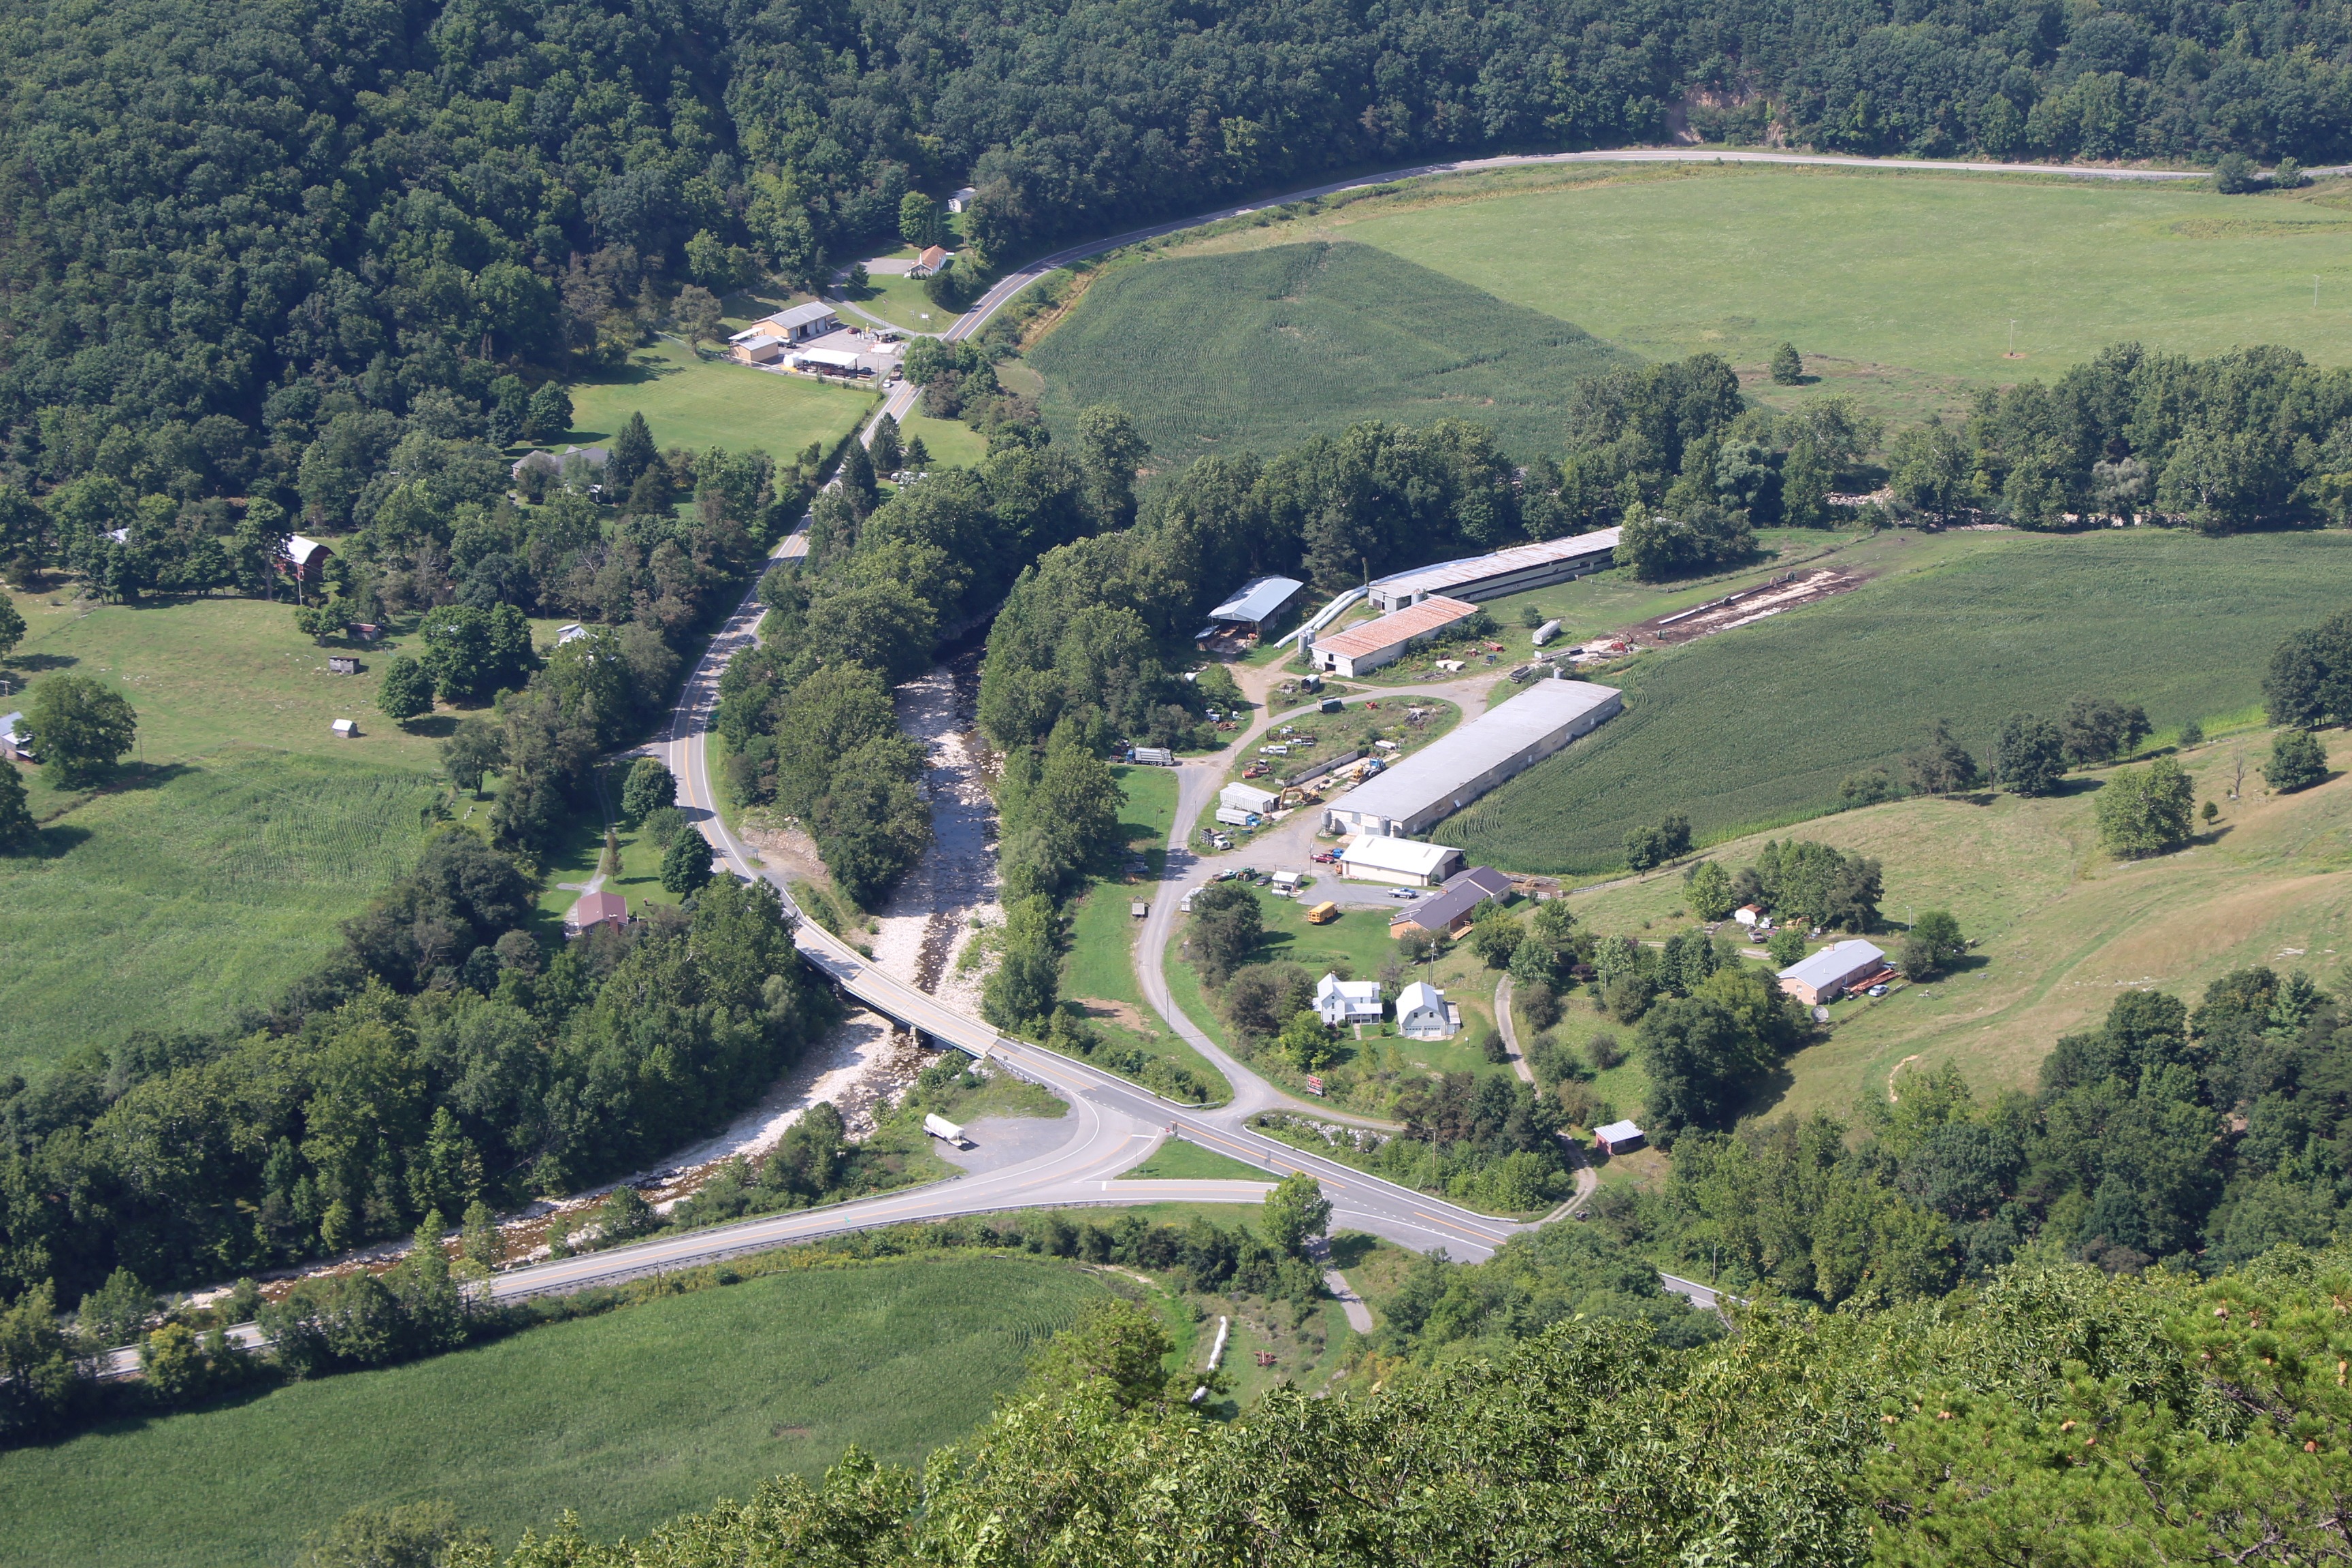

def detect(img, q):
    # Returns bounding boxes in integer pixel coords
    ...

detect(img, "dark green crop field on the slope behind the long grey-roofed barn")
[1433,529,2352,875]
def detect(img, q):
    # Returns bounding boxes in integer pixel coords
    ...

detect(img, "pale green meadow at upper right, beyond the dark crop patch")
[1129,165,2352,430]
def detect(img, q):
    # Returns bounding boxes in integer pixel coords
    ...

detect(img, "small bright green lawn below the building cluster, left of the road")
[569,338,875,459]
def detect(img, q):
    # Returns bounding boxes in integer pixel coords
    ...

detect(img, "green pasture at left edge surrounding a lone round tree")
[0,595,463,1072]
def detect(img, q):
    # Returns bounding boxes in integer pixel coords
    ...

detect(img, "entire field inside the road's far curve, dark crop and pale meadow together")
[1049,165,2352,442]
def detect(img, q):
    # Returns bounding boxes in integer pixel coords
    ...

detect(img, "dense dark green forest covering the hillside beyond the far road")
[0,0,2352,536]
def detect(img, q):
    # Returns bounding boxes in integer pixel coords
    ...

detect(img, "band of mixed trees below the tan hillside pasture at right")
[1595,968,2352,1305]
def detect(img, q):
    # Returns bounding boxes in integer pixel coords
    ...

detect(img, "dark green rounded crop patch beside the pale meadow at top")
[1028,244,1620,463]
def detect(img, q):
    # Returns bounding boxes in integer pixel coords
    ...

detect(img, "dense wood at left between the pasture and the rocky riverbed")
[0,851,835,1354]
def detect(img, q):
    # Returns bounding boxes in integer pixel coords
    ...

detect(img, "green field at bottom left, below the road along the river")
[0,1256,1105,1568]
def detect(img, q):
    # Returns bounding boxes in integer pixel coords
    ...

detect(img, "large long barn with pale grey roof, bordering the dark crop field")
[1324,679,1625,837]
